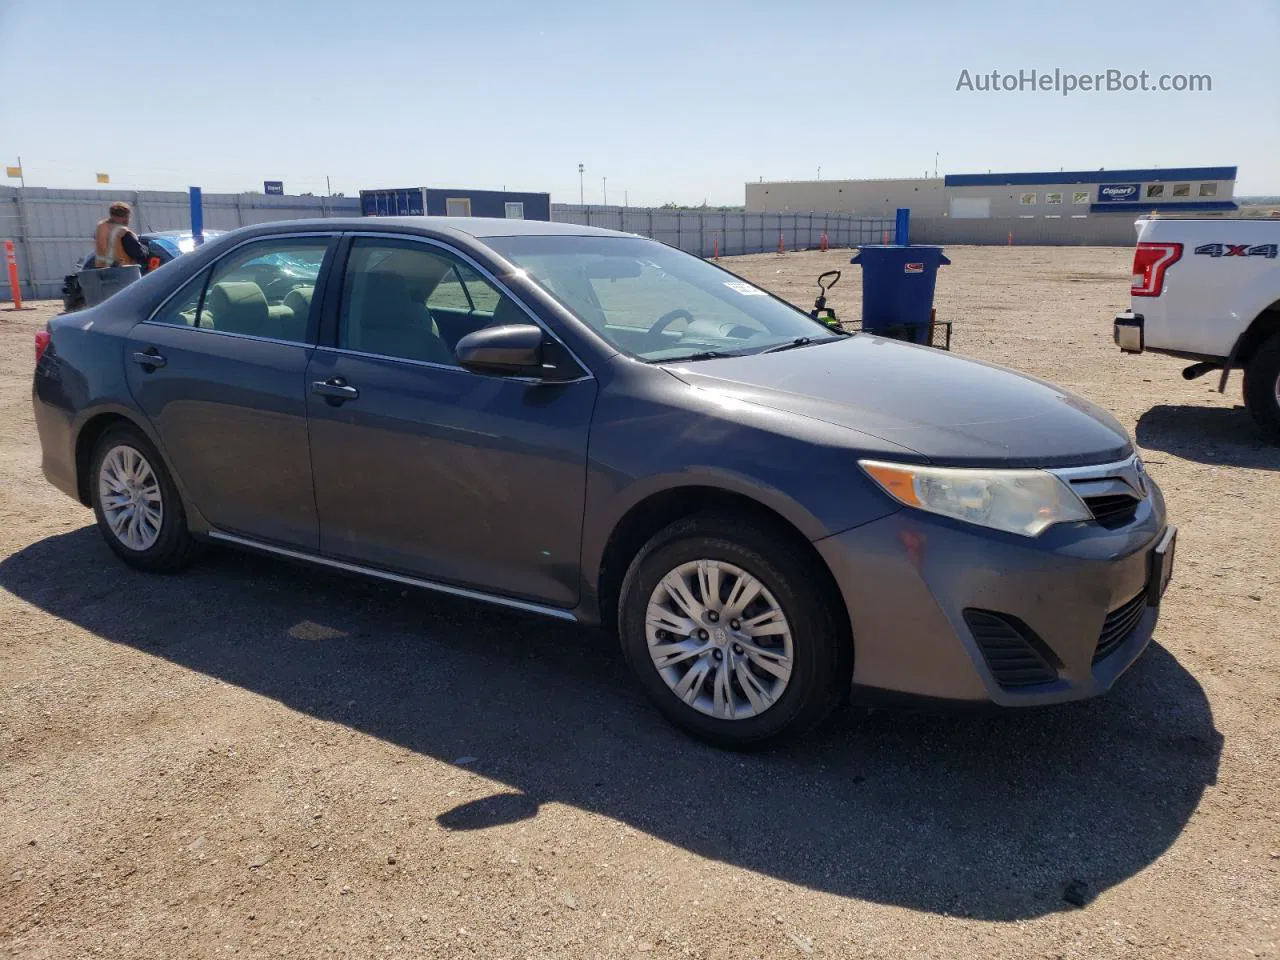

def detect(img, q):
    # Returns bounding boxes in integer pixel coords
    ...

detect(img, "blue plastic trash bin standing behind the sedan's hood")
[849,243,951,343]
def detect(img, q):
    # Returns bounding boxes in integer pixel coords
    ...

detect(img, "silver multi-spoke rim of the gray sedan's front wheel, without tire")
[645,558,795,721]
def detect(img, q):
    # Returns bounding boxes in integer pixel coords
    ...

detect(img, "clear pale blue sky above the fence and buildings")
[0,0,1280,205]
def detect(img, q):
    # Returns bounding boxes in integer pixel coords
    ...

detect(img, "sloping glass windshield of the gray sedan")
[485,236,838,361]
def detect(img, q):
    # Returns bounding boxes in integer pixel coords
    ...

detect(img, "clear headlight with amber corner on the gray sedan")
[859,460,1093,536]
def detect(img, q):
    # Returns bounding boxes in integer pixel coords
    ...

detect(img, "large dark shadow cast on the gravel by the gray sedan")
[0,527,1221,920]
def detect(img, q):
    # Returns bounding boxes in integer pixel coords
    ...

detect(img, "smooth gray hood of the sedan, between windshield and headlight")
[664,334,1132,467]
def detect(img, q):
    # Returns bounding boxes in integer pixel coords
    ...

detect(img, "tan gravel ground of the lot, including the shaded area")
[0,247,1280,960]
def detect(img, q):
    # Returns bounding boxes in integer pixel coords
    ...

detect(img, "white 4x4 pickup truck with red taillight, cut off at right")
[1115,218,1280,443]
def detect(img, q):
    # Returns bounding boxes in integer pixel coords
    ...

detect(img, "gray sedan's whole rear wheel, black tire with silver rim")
[90,424,197,573]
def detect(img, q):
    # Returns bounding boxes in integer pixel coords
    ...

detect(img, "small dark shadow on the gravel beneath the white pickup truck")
[1134,403,1280,470]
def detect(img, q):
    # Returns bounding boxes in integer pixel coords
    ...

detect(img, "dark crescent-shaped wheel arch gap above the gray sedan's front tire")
[595,484,852,660]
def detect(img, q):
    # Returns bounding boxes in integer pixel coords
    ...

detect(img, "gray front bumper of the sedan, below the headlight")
[815,484,1172,707]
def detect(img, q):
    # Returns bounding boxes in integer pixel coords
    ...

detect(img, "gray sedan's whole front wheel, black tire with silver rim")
[618,515,852,749]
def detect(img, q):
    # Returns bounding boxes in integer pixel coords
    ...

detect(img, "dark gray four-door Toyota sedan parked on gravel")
[33,218,1174,746]
